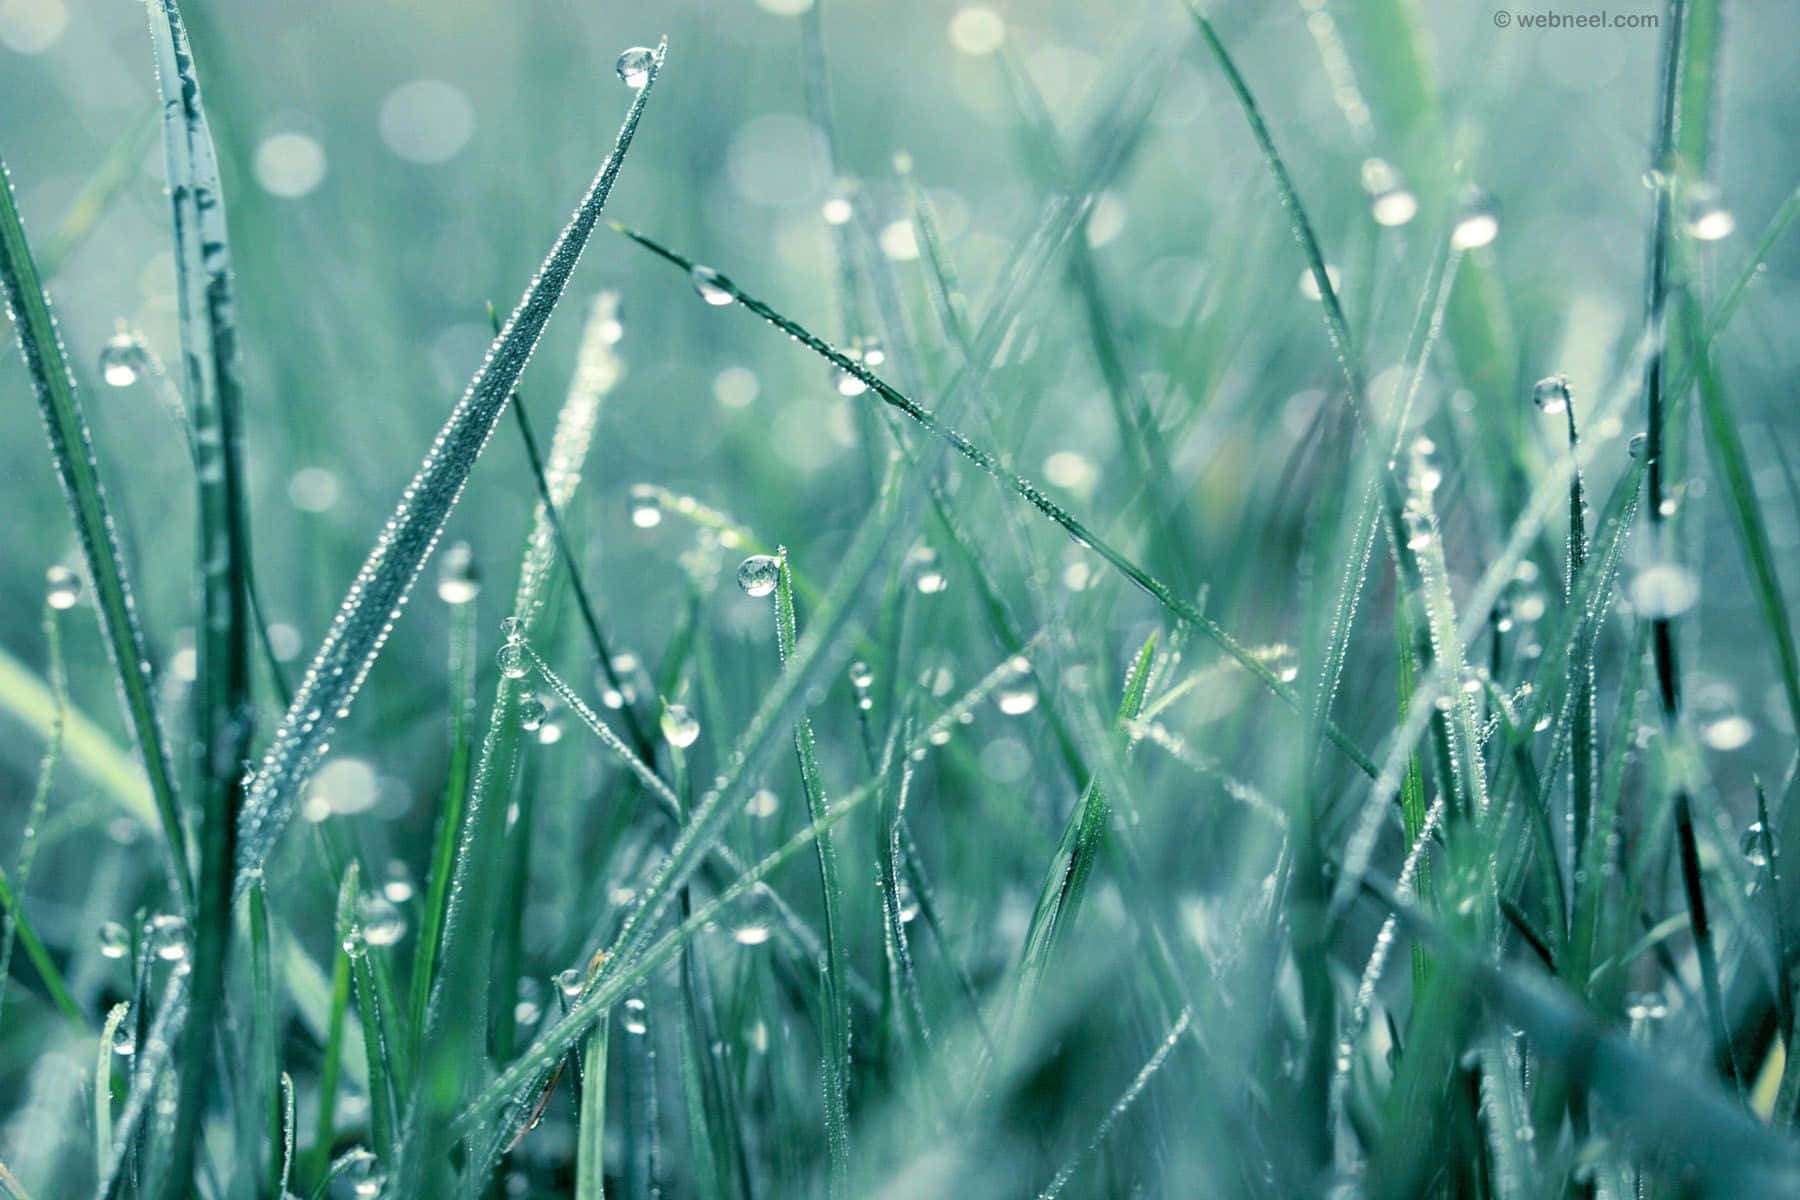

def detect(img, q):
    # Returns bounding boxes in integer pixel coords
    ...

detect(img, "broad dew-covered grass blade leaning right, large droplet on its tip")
[238,40,668,889]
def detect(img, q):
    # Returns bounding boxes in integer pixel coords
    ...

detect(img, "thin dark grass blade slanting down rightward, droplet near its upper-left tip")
[614,223,1379,777]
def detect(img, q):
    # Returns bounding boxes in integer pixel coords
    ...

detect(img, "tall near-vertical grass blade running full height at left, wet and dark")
[146,0,254,1196]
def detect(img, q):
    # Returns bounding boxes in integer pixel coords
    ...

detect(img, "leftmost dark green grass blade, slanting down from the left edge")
[0,152,193,905]
